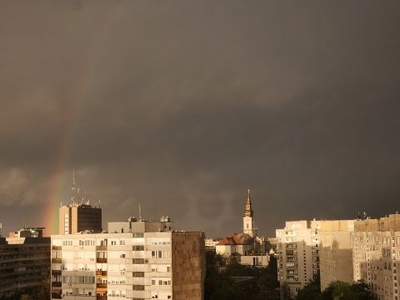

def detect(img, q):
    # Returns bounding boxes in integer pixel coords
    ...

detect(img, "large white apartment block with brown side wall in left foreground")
[51,217,205,300]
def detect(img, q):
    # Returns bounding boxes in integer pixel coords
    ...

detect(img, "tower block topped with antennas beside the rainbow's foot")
[59,173,102,234]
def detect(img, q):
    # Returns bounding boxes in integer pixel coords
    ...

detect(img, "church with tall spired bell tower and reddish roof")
[215,189,269,266]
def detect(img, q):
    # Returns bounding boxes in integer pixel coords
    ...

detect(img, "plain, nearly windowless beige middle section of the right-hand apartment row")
[319,220,354,291]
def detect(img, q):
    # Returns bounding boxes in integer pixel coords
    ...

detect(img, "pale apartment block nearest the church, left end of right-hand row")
[275,220,321,297]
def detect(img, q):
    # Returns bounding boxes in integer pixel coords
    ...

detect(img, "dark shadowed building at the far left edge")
[0,227,50,299]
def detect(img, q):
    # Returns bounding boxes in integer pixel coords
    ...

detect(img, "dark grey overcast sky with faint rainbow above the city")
[0,0,400,236]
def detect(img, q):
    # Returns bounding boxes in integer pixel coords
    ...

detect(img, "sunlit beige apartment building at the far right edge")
[352,213,400,300]
